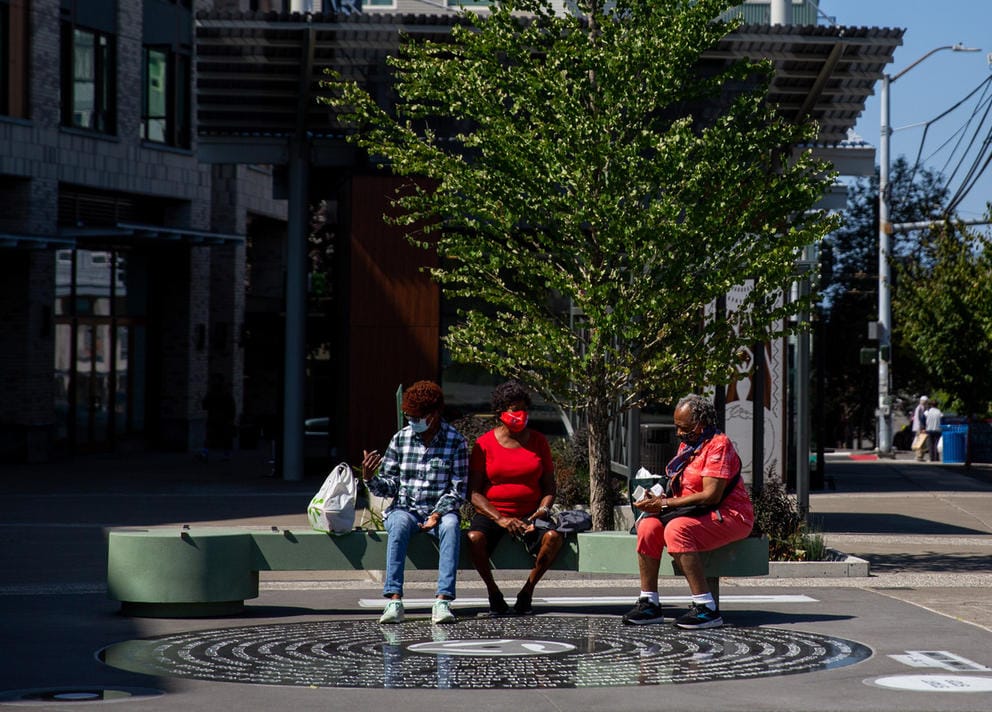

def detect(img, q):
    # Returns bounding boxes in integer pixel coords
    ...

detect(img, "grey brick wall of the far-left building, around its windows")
[0,0,294,459]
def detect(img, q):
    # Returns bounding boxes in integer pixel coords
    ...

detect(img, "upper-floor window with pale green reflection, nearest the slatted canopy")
[141,47,190,148]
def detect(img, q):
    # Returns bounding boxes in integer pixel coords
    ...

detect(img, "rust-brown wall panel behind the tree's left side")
[347,176,440,463]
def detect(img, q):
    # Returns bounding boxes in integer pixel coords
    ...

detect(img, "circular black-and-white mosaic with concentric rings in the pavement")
[102,616,871,688]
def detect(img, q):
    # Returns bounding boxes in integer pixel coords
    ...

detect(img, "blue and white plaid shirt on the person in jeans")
[368,421,468,519]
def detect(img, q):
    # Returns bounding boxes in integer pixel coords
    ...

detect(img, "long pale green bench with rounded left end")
[107,527,768,618]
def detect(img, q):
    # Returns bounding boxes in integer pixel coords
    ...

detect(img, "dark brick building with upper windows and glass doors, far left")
[0,0,285,461]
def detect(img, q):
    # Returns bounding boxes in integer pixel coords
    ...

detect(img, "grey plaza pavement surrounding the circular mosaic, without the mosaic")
[0,451,992,712]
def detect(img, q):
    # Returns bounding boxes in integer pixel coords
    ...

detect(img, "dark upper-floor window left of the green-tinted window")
[62,22,117,134]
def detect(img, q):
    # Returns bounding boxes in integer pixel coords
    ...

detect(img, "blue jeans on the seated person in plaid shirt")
[382,509,462,598]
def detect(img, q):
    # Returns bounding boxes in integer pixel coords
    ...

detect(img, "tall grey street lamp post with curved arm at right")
[876,44,981,455]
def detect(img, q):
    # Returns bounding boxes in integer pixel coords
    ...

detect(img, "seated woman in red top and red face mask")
[468,381,563,615]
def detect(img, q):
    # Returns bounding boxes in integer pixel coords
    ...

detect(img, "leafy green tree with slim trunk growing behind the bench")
[333,0,834,517]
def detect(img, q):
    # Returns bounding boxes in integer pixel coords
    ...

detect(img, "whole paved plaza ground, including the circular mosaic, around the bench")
[0,452,992,712]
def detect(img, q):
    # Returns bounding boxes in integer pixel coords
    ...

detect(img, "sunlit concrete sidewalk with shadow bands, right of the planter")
[810,452,992,630]
